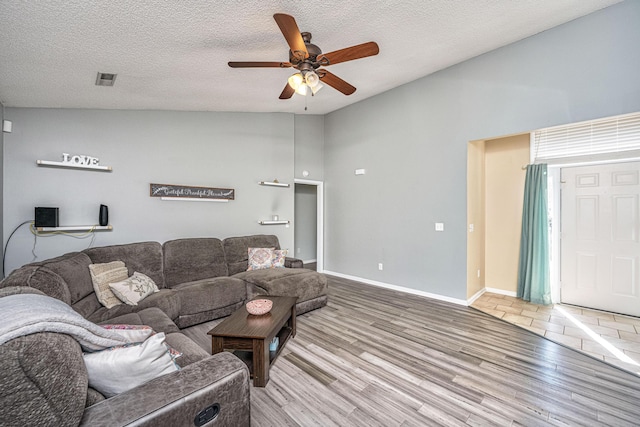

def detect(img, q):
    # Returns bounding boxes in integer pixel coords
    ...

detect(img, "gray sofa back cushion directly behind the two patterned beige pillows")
[83,242,165,289]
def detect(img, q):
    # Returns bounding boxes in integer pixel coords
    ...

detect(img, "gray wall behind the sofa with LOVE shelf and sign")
[3,108,294,273]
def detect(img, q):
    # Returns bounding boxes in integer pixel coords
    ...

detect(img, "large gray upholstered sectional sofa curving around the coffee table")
[0,235,327,426]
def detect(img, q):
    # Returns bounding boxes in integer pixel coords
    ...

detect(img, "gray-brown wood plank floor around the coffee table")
[185,276,640,427]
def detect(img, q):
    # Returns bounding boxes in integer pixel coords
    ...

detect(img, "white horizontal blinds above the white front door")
[532,113,640,164]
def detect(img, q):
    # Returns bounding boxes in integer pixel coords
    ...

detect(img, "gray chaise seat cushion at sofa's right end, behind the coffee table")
[233,268,327,302]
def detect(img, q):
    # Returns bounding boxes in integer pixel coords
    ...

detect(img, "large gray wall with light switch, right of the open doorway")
[324,1,640,300]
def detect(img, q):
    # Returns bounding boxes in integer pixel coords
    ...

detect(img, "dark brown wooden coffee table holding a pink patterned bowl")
[207,296,298,387]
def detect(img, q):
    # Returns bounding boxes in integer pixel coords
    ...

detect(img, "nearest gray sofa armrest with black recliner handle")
[81,352,251,427]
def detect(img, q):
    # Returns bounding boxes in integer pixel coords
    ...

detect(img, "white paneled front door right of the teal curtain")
[560,162,640,316]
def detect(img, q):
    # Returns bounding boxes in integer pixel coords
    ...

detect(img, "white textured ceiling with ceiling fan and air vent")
[0,0,619,114]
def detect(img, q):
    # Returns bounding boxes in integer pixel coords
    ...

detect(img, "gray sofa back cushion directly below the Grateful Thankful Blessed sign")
[162,238,228,288]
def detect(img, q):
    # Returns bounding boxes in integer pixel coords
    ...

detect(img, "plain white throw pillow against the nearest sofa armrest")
[83,332,180,398]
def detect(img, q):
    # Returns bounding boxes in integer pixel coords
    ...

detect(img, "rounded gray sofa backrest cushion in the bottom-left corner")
[0,332,87,426]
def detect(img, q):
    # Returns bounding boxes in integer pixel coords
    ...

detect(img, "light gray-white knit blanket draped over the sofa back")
[0,294,128,352]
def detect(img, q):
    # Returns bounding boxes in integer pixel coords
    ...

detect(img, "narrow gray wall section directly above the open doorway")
[294,115,324,181]
